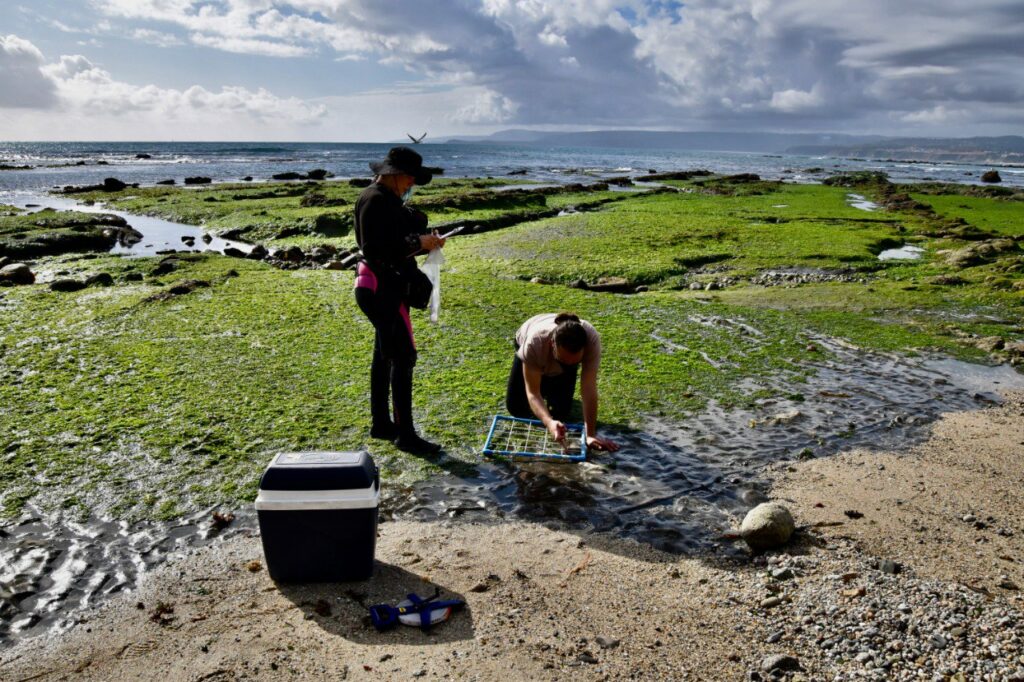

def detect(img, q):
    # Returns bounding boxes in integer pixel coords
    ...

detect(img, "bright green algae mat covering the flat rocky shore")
[0,180,1024,519]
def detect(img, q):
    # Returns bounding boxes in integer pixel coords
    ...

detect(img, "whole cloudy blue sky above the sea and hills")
[0,0,1024,142]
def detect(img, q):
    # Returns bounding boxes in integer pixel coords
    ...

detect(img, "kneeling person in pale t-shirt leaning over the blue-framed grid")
[505,312,618,453]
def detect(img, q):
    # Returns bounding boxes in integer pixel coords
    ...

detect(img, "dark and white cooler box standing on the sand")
[256,452,380,583]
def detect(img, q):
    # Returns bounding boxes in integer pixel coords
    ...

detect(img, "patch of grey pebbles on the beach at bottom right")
[728,541,1024,682]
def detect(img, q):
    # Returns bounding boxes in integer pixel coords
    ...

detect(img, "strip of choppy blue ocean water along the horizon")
[0,142,1024,198]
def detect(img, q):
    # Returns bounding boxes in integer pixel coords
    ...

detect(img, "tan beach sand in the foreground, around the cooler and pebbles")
[0,392,1024,681]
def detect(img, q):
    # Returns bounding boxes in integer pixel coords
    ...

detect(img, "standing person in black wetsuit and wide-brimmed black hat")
[355,146,444,455]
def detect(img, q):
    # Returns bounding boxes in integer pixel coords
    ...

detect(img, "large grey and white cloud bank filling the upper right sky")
[68,0,1024,132]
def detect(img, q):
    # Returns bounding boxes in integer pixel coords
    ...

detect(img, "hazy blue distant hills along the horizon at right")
[437,129,1024,163]
